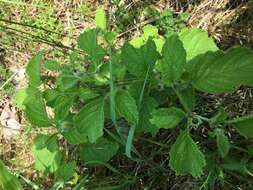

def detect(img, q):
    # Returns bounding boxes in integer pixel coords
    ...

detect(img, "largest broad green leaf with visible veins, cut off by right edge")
[189,48,253,93]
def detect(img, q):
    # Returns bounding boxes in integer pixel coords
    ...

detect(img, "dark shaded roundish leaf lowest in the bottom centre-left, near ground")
[80,138,119,163]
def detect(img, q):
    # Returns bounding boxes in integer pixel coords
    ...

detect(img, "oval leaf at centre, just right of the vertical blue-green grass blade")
[115,90,139,124]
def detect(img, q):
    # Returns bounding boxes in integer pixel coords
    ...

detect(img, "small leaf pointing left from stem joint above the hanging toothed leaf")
[150,107,185,129]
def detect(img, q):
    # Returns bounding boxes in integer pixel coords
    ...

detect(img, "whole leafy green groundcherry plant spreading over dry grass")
[7,8,253,189]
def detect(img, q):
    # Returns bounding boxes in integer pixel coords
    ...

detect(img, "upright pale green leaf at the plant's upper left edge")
[26,52,43,87]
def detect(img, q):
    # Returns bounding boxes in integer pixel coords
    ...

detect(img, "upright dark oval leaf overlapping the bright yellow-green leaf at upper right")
[160,34,186,84]
